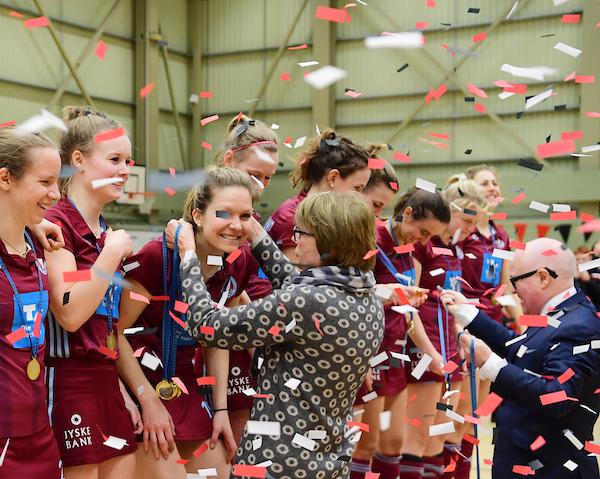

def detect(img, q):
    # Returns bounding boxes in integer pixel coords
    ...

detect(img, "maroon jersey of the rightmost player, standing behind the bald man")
[462,221,510,321]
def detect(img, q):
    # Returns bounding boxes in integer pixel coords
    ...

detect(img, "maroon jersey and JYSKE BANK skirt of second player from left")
[46,198,137,467]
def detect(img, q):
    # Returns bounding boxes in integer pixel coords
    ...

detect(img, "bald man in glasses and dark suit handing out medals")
[442,238,600,479]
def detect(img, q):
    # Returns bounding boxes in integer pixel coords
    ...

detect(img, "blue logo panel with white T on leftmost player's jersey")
[11,291,48,349]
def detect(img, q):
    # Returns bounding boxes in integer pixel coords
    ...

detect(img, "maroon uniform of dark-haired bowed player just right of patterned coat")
[356,222,415,404]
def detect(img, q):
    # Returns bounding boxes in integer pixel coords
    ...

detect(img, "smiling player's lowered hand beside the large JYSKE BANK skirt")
[142,395,175,460]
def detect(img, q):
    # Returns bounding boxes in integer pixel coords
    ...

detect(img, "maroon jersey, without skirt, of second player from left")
[46,198,121,359]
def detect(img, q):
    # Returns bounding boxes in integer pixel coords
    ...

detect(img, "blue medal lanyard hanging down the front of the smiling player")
[162,225,183,380]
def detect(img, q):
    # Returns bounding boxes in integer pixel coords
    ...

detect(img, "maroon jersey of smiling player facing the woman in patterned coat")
[126,238,256,384]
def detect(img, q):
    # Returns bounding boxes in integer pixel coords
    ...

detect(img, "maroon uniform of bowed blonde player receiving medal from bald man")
[407,236,464,383]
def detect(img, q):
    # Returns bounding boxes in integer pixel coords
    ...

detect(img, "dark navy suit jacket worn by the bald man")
[467,291,600,479]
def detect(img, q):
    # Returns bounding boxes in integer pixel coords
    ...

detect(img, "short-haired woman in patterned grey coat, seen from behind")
[168,192,384,479]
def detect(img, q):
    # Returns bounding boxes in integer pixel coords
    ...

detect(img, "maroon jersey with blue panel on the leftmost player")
[0,236,49,438]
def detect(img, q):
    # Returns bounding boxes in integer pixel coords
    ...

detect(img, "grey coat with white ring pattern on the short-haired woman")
[181,235,384,479]
